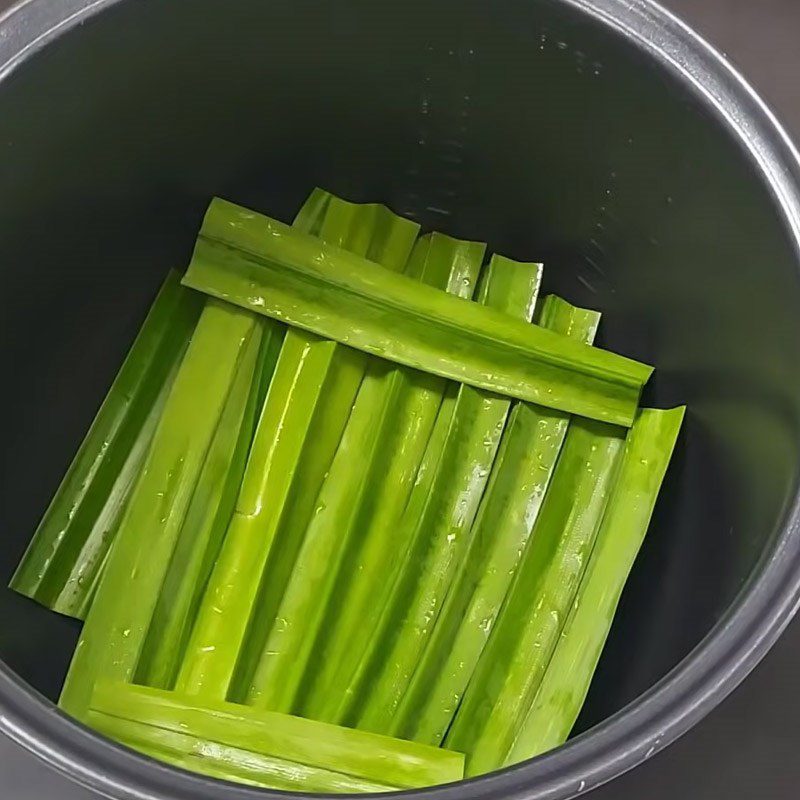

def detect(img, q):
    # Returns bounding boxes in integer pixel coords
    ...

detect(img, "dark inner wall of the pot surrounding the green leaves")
[0,0,800,740]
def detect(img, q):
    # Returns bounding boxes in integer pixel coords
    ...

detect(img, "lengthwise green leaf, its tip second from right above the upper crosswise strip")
[350,256,541,735]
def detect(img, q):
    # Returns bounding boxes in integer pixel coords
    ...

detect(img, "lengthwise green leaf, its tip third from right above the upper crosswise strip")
[249,234,485,721]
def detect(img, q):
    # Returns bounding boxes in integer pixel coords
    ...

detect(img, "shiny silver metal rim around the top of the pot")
[0,0,800,800]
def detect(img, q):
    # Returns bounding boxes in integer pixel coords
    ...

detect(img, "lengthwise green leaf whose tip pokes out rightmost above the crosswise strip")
[391,295,600,744]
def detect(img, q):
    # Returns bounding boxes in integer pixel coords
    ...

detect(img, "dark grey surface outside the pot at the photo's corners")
[0,0,800,800]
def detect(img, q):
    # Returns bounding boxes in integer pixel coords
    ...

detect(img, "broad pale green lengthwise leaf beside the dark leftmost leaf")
[60,300,261,718]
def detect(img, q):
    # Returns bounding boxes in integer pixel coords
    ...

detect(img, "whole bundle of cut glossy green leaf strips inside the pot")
[11,189,684,793]
